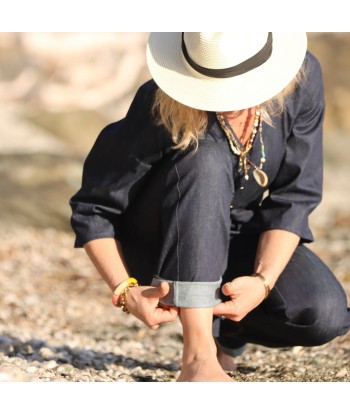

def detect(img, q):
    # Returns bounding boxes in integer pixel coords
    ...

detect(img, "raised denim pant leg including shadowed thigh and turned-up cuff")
[121,137,234,307]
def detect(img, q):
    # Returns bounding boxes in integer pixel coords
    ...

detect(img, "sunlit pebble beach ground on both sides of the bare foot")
[0,221,350,382]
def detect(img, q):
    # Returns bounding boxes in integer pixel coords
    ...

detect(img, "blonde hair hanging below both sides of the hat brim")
[152,68,305,150]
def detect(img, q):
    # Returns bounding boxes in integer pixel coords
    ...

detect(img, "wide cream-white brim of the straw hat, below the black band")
[147,32,307,111]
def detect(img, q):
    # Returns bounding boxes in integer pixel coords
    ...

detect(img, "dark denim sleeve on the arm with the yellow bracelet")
[70,83,169,247]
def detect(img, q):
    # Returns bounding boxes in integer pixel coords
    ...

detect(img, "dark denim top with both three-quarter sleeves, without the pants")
[70,53,324,247]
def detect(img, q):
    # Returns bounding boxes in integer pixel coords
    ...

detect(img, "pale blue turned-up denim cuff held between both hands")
[151,276,221,308]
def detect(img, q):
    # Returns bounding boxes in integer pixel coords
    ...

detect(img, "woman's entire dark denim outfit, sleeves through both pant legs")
[70,53,350,353]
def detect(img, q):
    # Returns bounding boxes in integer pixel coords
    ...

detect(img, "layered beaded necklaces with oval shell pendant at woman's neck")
[216,107,269,187]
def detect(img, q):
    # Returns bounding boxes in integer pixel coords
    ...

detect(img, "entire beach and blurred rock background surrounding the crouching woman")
[0,33,350,381]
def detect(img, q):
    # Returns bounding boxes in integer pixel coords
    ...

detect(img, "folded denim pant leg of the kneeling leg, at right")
[214,239,350,349]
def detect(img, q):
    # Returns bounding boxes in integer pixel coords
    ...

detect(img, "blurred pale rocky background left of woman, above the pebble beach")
[0,33,148,230]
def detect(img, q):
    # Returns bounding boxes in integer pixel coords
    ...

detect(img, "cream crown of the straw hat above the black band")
[184,32,268,69]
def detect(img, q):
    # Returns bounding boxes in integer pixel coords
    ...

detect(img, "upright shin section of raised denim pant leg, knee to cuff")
[152,139,234,307]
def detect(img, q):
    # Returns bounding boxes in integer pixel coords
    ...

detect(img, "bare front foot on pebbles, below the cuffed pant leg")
[177,358,235,382]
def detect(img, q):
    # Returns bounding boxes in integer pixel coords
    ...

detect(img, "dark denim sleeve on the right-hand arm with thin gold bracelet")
[260,59,325,242]
